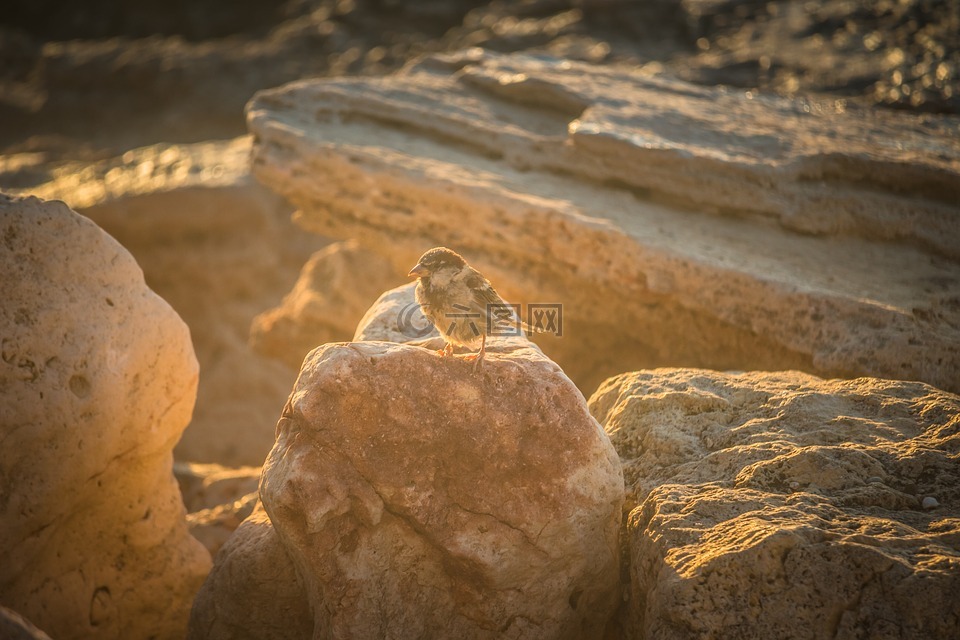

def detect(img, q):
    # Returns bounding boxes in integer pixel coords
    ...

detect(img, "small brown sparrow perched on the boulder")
[407,247,523,369]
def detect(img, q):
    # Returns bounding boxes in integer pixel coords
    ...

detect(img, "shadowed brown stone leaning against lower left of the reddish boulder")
[187,503,310,640]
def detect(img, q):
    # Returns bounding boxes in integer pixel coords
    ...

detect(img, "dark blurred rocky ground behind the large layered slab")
[0,0,960,160]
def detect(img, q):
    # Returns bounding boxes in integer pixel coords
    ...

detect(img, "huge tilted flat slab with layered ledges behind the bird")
[248,50,960,391]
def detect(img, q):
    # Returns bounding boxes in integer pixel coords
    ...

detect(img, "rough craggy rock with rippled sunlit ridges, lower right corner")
[590,369,960,639]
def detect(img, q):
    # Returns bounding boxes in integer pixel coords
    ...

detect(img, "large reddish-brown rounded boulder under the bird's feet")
[191,285,623,638]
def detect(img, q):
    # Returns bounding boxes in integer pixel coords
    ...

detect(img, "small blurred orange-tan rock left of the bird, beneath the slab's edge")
[250,241,404,369]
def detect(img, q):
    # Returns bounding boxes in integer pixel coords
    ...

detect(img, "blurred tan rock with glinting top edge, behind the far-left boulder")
[0,137,322,465]
